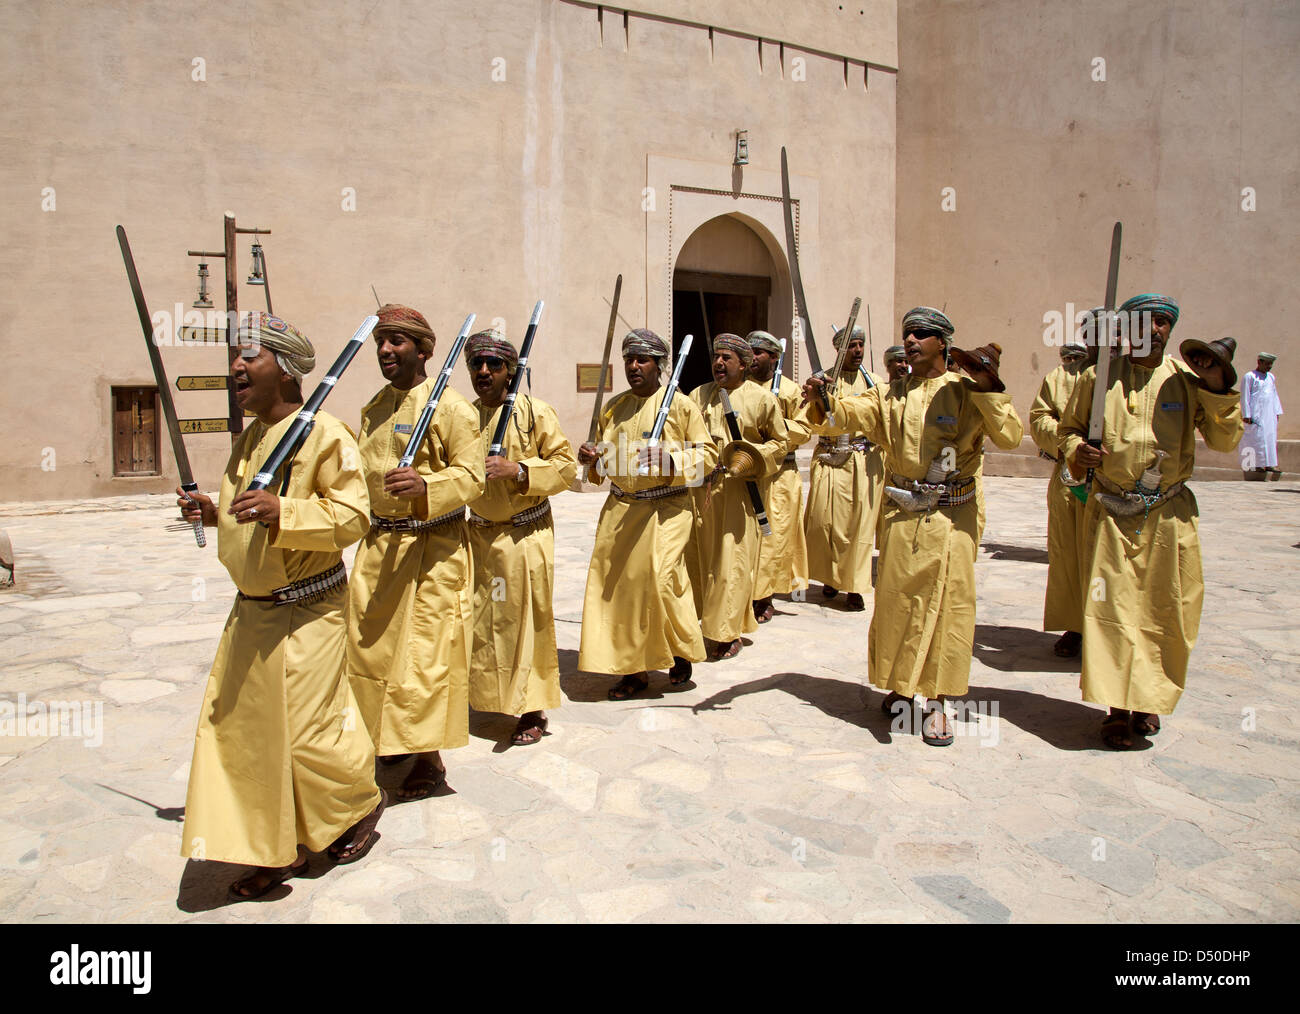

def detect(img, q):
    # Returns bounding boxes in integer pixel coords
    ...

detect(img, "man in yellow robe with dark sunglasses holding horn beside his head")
[805,307,1024,746]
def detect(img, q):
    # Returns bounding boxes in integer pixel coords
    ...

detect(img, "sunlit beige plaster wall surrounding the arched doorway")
[0,0,894,501]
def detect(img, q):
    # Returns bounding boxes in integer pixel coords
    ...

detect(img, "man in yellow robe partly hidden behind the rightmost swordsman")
[1030,326,1097,658]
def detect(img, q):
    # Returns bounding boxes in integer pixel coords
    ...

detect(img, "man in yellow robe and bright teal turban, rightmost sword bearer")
[1060,293,1244,750]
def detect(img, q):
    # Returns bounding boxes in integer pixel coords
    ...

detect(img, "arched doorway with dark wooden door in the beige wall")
[672,215,790,391]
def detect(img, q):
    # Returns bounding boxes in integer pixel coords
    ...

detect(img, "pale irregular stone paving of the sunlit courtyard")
[0,478,1300,923]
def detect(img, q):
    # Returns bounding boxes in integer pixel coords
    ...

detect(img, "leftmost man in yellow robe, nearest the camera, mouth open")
[177,313,386,900]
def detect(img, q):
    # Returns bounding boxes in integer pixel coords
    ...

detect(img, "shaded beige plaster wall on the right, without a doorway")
[894,0,1300,477]
